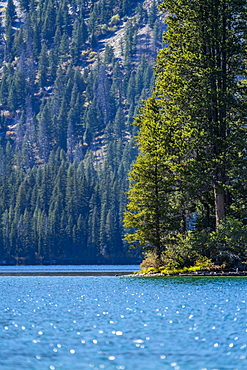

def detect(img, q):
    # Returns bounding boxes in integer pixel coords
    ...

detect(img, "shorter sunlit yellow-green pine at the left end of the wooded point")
[124,98,179,258]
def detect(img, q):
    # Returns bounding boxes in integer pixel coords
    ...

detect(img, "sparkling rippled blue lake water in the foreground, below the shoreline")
[0,276,247,370]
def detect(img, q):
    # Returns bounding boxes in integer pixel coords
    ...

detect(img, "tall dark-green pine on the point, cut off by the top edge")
[156,0,246,226]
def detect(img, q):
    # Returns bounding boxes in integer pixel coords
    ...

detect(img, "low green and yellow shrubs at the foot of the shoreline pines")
[141,217,247,273]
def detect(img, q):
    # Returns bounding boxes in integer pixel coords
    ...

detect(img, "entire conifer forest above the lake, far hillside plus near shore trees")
[0,0,247,271]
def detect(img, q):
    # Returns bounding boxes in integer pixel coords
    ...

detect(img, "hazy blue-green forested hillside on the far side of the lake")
[0,0,163,263]
